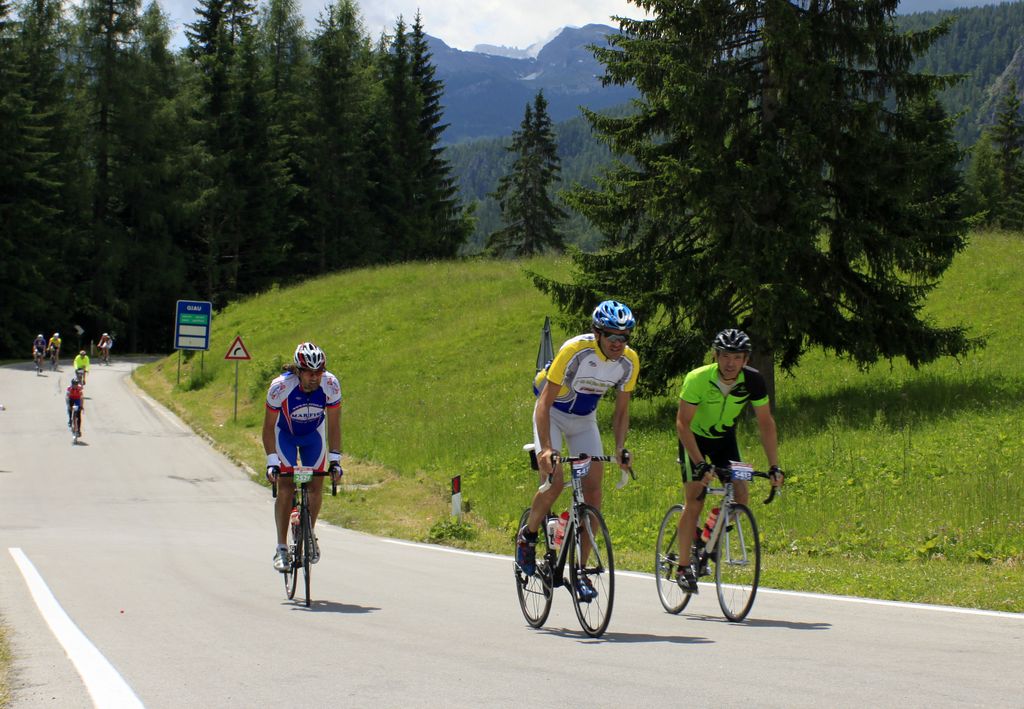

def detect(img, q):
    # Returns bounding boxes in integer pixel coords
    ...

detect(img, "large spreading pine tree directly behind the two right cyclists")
[536,0,975,391]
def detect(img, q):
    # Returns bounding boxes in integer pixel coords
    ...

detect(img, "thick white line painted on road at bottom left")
[7,548,143,709]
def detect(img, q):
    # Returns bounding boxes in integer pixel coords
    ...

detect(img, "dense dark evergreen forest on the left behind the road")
[0,0,470,357]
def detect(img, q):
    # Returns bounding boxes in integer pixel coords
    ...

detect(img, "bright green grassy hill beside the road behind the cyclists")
[136,233,1024,612]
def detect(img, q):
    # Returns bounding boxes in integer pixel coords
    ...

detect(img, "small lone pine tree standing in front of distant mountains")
[487,91,566,256]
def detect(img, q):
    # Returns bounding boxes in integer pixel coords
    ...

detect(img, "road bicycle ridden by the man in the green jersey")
[654,462,777,622]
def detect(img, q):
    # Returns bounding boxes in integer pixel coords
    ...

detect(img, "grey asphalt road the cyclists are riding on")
[0,361,1024,709]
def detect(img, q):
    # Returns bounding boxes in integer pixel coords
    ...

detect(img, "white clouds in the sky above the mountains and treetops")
[154,0,643,49]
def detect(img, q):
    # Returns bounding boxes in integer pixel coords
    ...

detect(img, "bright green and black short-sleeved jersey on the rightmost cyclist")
[679,364,768,439]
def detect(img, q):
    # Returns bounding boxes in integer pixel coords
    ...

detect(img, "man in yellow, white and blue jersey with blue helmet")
[516,300,640,601]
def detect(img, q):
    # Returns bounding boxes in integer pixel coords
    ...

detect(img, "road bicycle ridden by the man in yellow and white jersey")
[513,444,632,637]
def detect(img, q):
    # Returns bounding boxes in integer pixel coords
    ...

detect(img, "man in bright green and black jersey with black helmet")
[676,329,784,593]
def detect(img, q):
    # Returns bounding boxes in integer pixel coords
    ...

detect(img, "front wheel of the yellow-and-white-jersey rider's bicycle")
[565,504,615,637]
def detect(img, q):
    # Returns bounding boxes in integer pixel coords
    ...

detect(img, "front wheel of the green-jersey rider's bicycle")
[715,504,761,622]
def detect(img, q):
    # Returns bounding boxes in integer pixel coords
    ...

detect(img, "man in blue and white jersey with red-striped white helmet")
[263,342,343,573]
